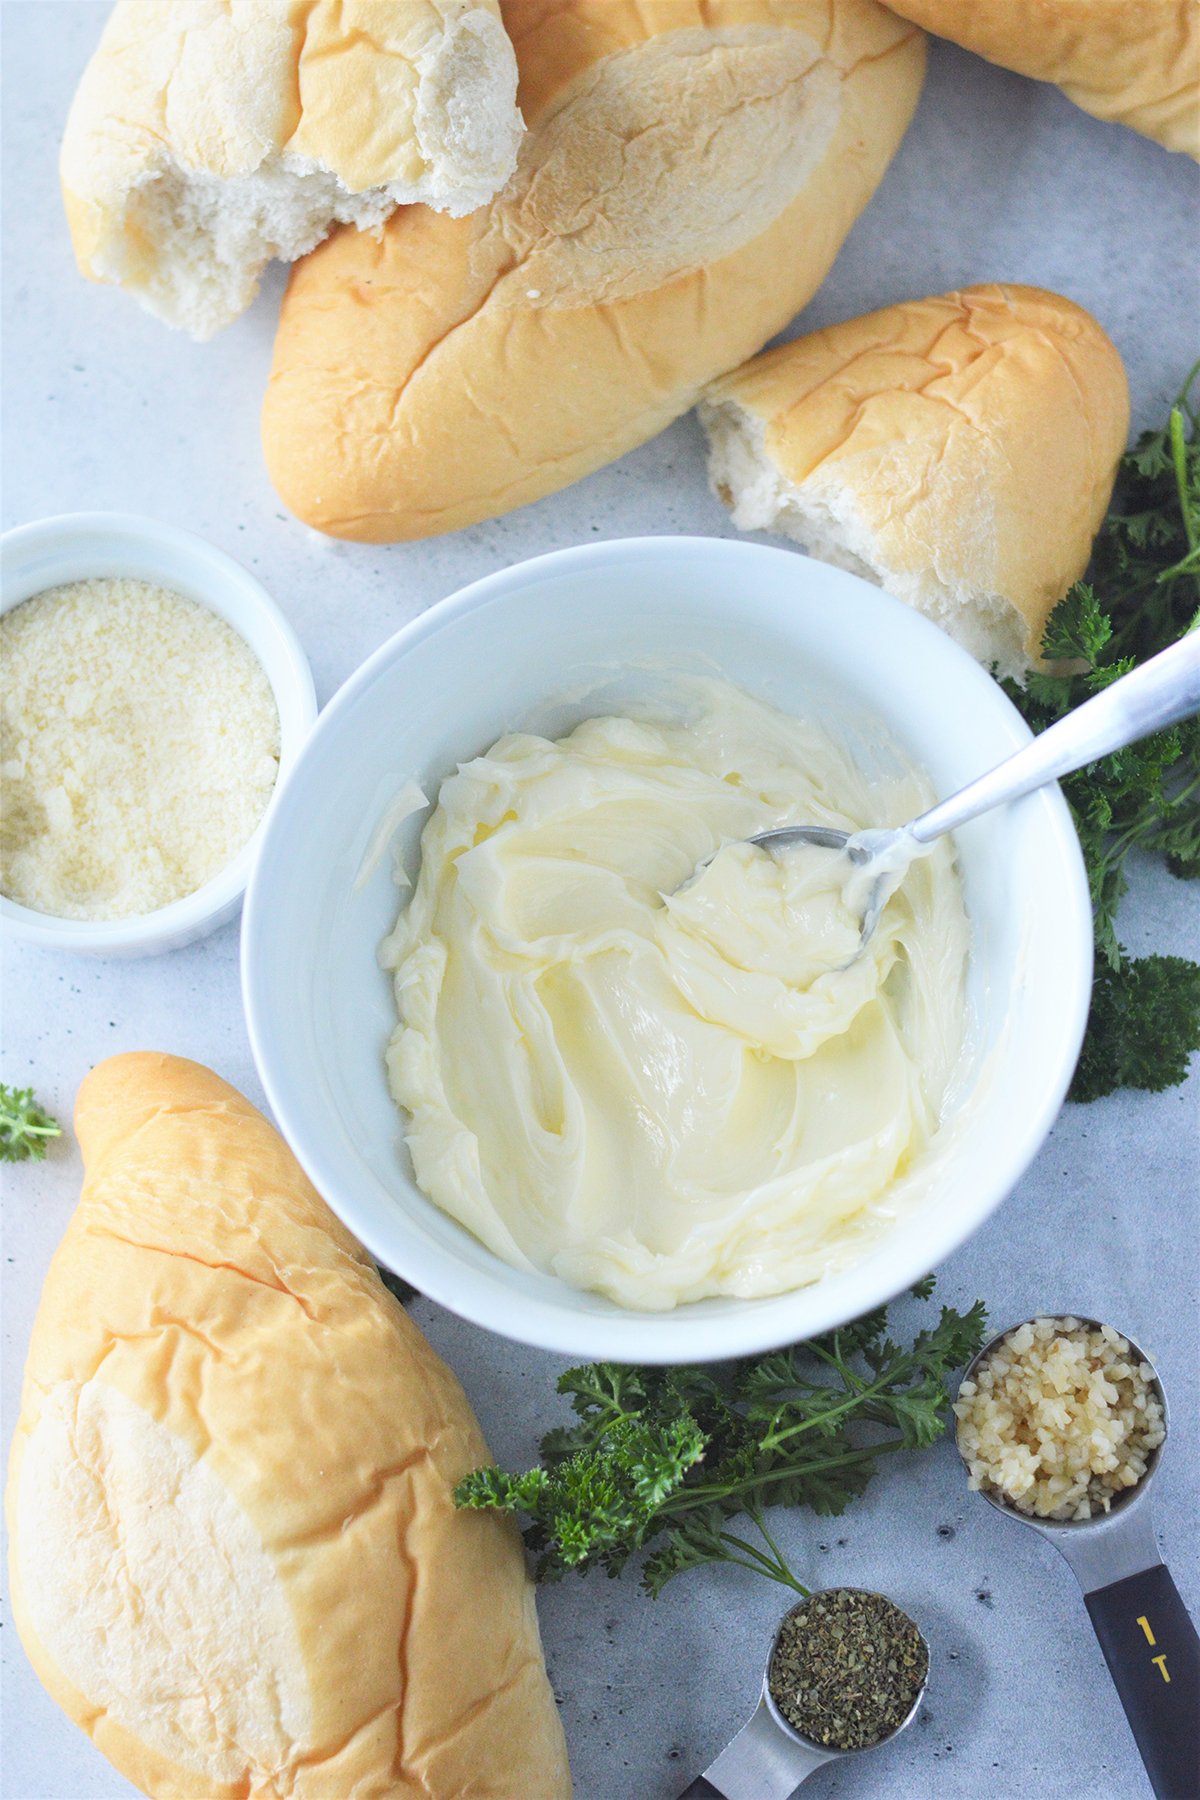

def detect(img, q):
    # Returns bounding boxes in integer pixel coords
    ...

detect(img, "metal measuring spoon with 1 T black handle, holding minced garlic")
[955,1312,1200,1800]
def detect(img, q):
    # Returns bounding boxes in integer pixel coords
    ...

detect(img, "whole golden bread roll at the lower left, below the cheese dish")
[7,1055,570,1800]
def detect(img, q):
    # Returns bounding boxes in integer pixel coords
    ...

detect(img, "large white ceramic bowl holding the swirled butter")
[243,538,1092,1363]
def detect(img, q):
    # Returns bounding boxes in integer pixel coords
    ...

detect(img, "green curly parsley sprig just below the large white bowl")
[455,1276,986,1597]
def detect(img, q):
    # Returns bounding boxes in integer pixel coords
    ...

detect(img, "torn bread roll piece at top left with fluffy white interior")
[61,0,522,338]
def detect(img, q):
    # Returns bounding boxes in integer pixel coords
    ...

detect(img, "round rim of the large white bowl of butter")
[241,533,1092,1364]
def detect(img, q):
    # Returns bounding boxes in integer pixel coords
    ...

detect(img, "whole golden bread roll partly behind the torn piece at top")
[263,0,925,542]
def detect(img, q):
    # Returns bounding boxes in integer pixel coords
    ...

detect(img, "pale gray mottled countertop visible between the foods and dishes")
[0,0,1200,1800]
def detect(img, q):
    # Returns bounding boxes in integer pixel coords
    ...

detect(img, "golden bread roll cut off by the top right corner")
[877,0,1200,158]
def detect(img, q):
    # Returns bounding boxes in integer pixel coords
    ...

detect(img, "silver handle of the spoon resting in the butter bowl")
[909,630,1200,844]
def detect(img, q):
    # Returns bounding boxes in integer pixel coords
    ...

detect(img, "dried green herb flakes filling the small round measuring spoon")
[768,1588,928,1750]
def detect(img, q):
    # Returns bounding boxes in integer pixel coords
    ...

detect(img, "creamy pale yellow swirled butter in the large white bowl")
[381,680,968,1309]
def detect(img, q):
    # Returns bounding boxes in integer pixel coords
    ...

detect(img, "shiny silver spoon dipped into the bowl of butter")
[750,630,1200,954]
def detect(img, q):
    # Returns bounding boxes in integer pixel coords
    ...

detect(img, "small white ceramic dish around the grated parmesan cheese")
[0,513,317,956]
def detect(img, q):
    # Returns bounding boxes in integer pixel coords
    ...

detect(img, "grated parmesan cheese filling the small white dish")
[0,578,279,918]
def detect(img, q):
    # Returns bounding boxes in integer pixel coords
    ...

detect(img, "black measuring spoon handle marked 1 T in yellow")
[1085,1562,1200,1800]
